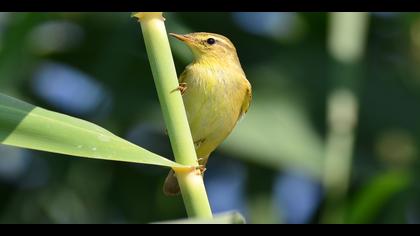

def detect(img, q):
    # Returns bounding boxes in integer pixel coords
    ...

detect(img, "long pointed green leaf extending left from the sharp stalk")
[0,94,184,168]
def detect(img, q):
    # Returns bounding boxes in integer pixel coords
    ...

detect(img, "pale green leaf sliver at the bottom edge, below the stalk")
[153,212,246,224]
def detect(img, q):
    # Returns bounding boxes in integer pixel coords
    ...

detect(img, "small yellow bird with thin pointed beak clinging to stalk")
[163,32,252,196]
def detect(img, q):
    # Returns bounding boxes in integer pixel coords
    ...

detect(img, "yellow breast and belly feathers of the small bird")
[183,64,246,155]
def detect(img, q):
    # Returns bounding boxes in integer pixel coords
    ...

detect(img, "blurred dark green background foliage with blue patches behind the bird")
[0,12,420,223]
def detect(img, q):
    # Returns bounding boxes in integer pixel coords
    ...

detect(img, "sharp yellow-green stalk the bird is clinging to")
[133,12,212,218]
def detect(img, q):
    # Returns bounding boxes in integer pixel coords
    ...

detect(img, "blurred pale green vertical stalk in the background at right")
[322,12,369,223]
